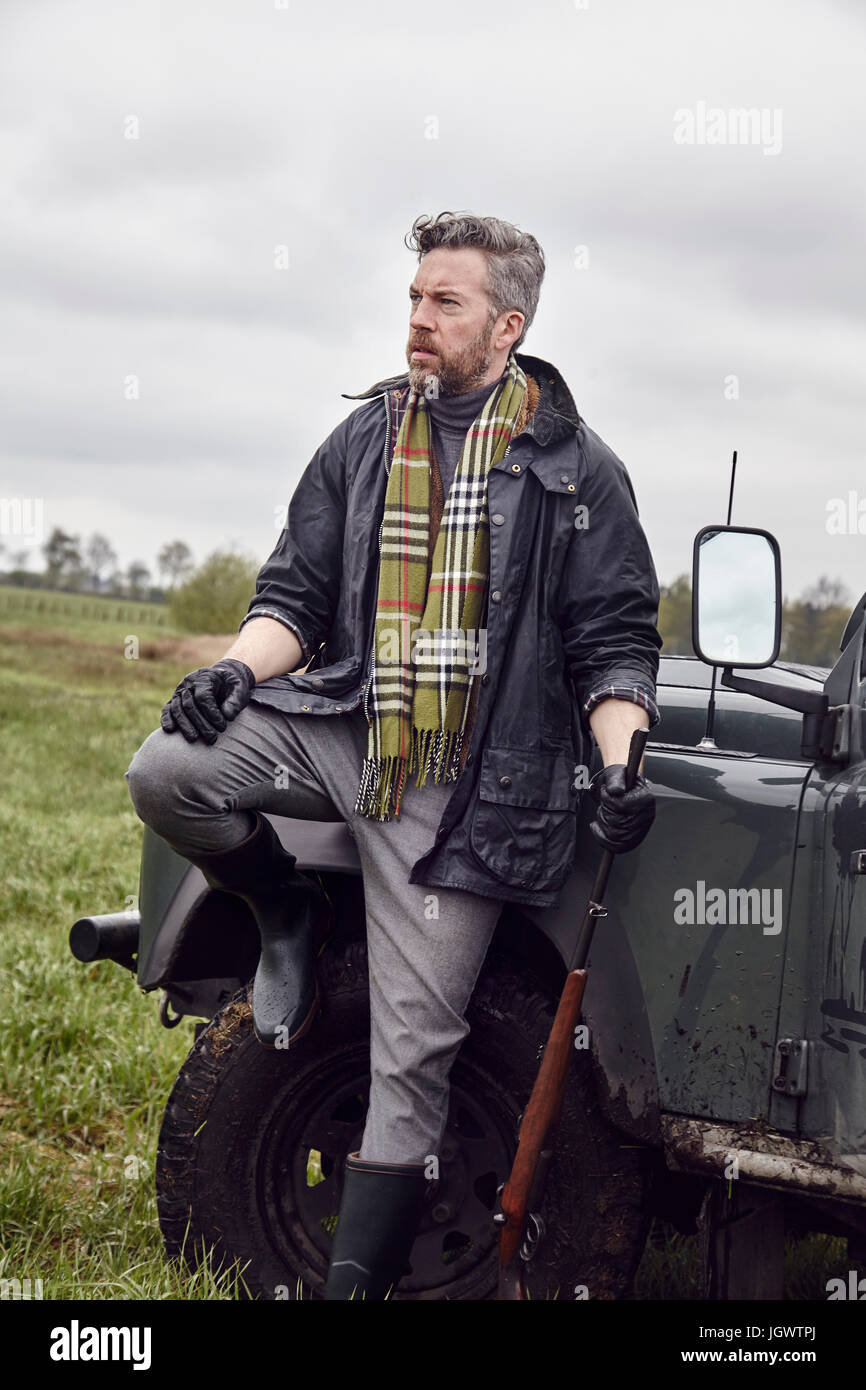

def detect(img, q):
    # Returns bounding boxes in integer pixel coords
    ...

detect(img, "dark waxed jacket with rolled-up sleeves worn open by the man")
[240,353,662,906]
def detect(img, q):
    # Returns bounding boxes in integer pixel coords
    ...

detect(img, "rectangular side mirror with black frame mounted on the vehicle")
[692,525,781,666]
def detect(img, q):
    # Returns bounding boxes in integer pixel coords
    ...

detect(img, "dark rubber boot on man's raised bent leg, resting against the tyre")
[185,810,329,1048]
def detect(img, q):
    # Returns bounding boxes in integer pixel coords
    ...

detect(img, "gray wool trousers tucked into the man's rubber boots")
[125,699,502,1163]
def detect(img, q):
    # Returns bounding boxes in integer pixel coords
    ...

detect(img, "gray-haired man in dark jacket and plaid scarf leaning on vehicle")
[126,213,660,1298]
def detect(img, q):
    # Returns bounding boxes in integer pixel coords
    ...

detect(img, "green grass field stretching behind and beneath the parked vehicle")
[0,589,849,1300]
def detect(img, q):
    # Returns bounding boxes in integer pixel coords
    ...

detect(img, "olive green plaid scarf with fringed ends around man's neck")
[354,354,527,820]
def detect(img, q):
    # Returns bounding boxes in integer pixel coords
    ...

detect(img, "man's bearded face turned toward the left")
[406,246,523,396]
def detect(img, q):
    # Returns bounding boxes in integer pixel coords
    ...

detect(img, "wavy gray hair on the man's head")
[405,213,545,352]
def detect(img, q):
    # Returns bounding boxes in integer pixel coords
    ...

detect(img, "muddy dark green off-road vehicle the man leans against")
[71,527,866,1300]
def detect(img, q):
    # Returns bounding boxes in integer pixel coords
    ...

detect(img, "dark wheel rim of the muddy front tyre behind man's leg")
[257,1058,517,1298]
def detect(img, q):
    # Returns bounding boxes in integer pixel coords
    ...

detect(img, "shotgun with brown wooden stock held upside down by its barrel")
[493,728,648,1301]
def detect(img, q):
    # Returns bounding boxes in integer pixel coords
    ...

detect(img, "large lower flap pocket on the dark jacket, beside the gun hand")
[470,748,577,891]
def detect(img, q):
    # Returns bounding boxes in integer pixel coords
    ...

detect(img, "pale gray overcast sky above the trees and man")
[0,0,866,600]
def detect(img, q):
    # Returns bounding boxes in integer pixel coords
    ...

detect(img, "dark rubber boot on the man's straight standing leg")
[324,1154,427,1301]
